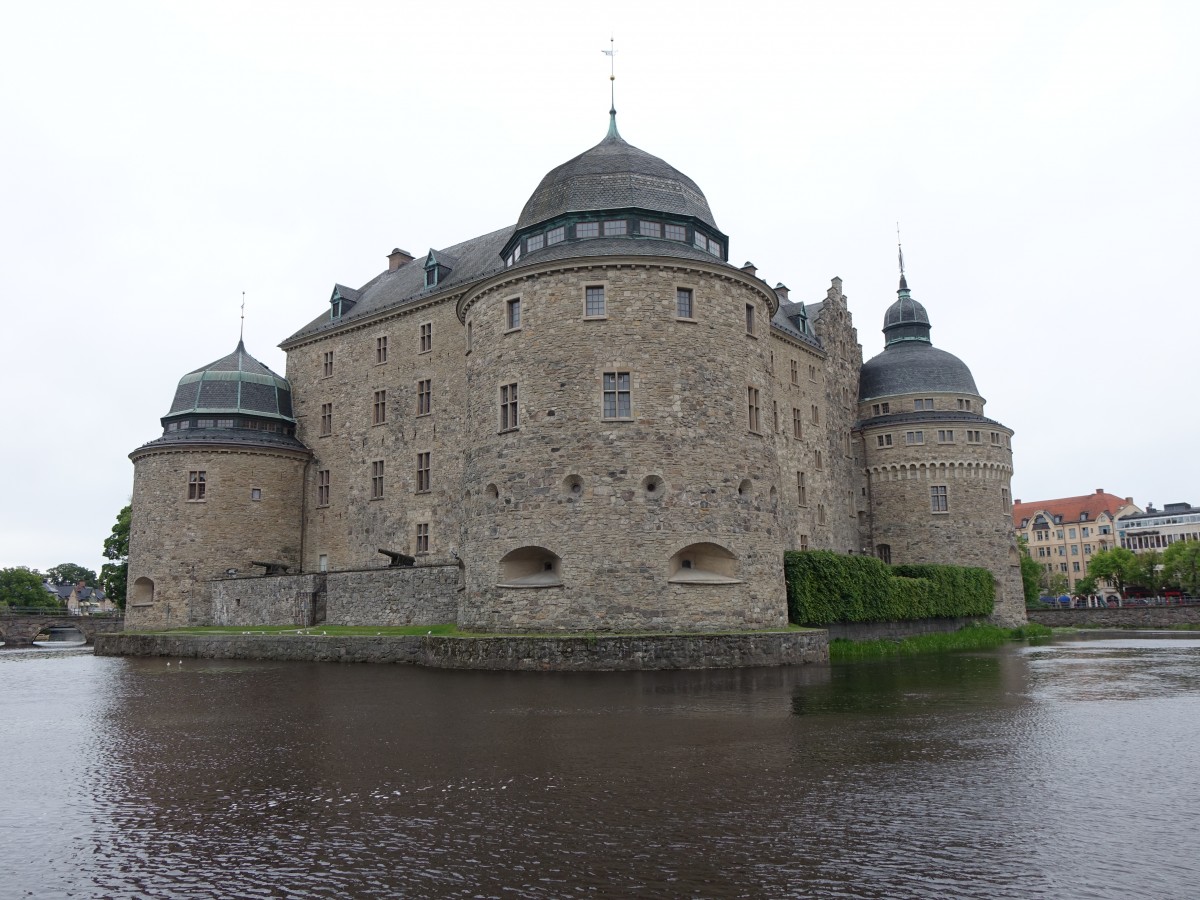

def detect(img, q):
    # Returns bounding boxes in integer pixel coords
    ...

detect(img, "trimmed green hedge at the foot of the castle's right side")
[784,550,995,625]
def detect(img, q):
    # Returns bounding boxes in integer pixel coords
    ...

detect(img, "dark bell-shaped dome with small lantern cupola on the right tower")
[858,274,979,401]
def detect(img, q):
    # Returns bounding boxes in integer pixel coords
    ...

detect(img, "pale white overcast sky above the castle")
[0,0,1200,578]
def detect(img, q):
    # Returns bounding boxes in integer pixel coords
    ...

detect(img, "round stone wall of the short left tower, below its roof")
[126,446,306,629]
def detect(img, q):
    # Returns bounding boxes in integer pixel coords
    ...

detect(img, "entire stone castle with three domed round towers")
[126,113,1024,631]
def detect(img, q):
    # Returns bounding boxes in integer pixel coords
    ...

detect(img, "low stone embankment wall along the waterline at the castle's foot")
[96,630,829,672]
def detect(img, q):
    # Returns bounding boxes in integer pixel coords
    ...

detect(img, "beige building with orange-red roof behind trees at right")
[1013,487,1141,590]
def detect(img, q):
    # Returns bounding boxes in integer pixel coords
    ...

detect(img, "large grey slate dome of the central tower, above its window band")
[517,124,716,230]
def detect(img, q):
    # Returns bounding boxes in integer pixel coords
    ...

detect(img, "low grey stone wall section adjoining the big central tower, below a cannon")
[325,564,462,625]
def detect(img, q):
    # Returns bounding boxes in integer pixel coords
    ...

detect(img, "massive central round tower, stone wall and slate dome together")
[457,114,786,630]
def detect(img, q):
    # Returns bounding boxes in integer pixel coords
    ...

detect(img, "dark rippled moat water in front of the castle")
[0,637,1200,899]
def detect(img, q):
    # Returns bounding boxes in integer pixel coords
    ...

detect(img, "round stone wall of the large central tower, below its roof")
[458,258,786,631]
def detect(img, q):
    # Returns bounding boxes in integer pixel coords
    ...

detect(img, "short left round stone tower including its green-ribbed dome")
[126,341,310,628]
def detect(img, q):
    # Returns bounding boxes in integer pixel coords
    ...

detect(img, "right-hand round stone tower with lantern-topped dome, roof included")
[858,274,1025,624]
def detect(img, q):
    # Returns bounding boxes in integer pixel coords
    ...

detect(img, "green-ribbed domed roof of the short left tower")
[164,341,295,424]
